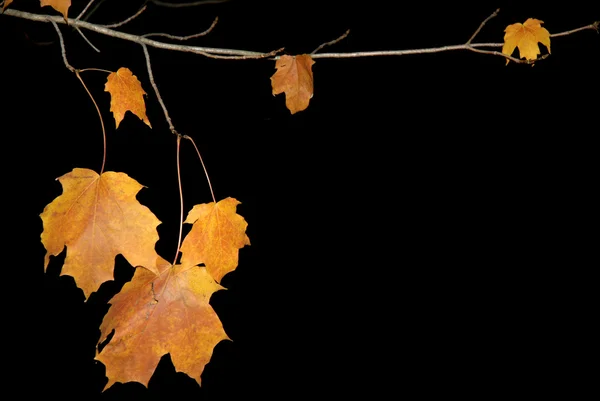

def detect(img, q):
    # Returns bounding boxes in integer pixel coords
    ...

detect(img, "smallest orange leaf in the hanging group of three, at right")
[181,198,250,282]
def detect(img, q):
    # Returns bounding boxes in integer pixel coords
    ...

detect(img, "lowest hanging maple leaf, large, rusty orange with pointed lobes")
[96,262,229,390]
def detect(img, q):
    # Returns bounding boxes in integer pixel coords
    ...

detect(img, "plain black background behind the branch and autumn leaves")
[0,0,600,400]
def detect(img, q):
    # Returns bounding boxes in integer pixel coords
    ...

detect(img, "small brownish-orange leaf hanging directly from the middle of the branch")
[271,54,315,114]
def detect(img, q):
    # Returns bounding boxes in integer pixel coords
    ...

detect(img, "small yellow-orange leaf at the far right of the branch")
[502,18,550,64]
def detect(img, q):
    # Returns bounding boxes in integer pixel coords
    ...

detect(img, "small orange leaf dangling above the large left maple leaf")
[104,67,152,128]
